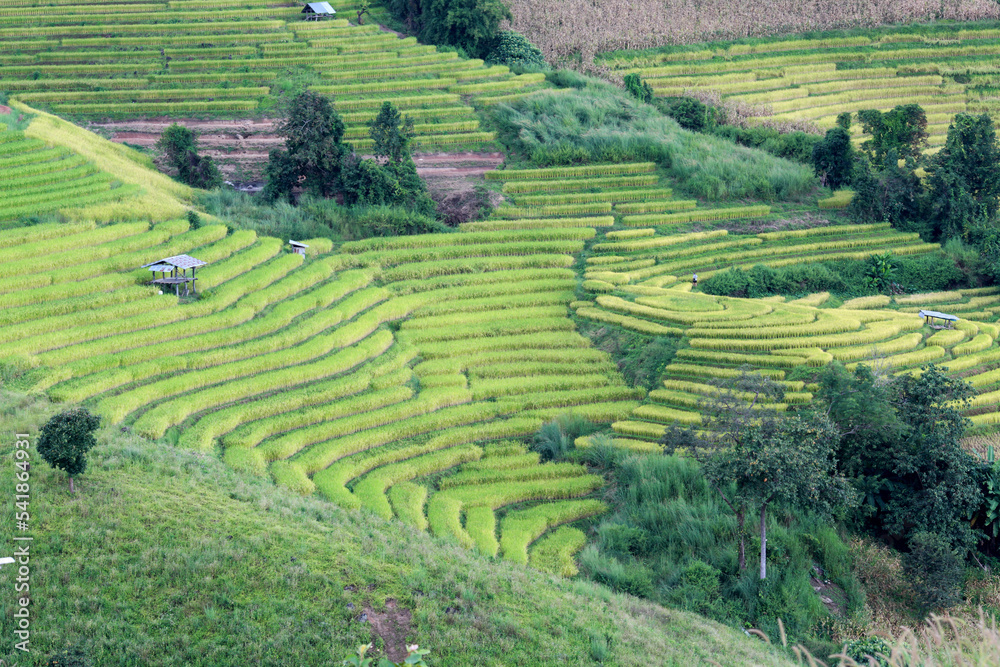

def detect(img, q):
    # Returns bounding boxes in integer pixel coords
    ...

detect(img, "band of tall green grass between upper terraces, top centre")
[492,79,815,201]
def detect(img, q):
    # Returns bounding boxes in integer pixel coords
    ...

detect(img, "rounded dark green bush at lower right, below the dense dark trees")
[903,532,964,614]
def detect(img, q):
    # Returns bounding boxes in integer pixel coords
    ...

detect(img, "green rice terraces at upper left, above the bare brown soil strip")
[0,0,544,150]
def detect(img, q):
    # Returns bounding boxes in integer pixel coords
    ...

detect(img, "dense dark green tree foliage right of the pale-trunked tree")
[820,364,985,553]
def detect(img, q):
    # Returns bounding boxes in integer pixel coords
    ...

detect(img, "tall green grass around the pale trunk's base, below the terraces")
[580,455,864,651]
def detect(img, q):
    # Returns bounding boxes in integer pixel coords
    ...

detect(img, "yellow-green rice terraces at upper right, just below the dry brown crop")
[603,25,1000,150]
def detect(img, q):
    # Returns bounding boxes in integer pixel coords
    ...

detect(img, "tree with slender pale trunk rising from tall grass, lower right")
[664,371,856,579]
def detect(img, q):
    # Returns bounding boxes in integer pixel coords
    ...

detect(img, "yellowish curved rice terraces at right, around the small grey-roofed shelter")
[573,224,1000,450]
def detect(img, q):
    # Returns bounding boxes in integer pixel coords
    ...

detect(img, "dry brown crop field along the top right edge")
[506,0,1000,66]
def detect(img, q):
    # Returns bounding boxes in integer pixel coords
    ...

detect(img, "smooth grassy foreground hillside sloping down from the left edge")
[0,394,790,667]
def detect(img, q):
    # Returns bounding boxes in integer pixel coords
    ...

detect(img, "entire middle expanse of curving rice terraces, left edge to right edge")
[7,116,1000,574]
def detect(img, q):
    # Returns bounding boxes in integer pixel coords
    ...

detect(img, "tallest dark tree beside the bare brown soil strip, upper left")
[264,91,347,201]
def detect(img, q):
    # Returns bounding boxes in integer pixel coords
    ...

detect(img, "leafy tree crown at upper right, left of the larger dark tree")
[858,104,927,169]
